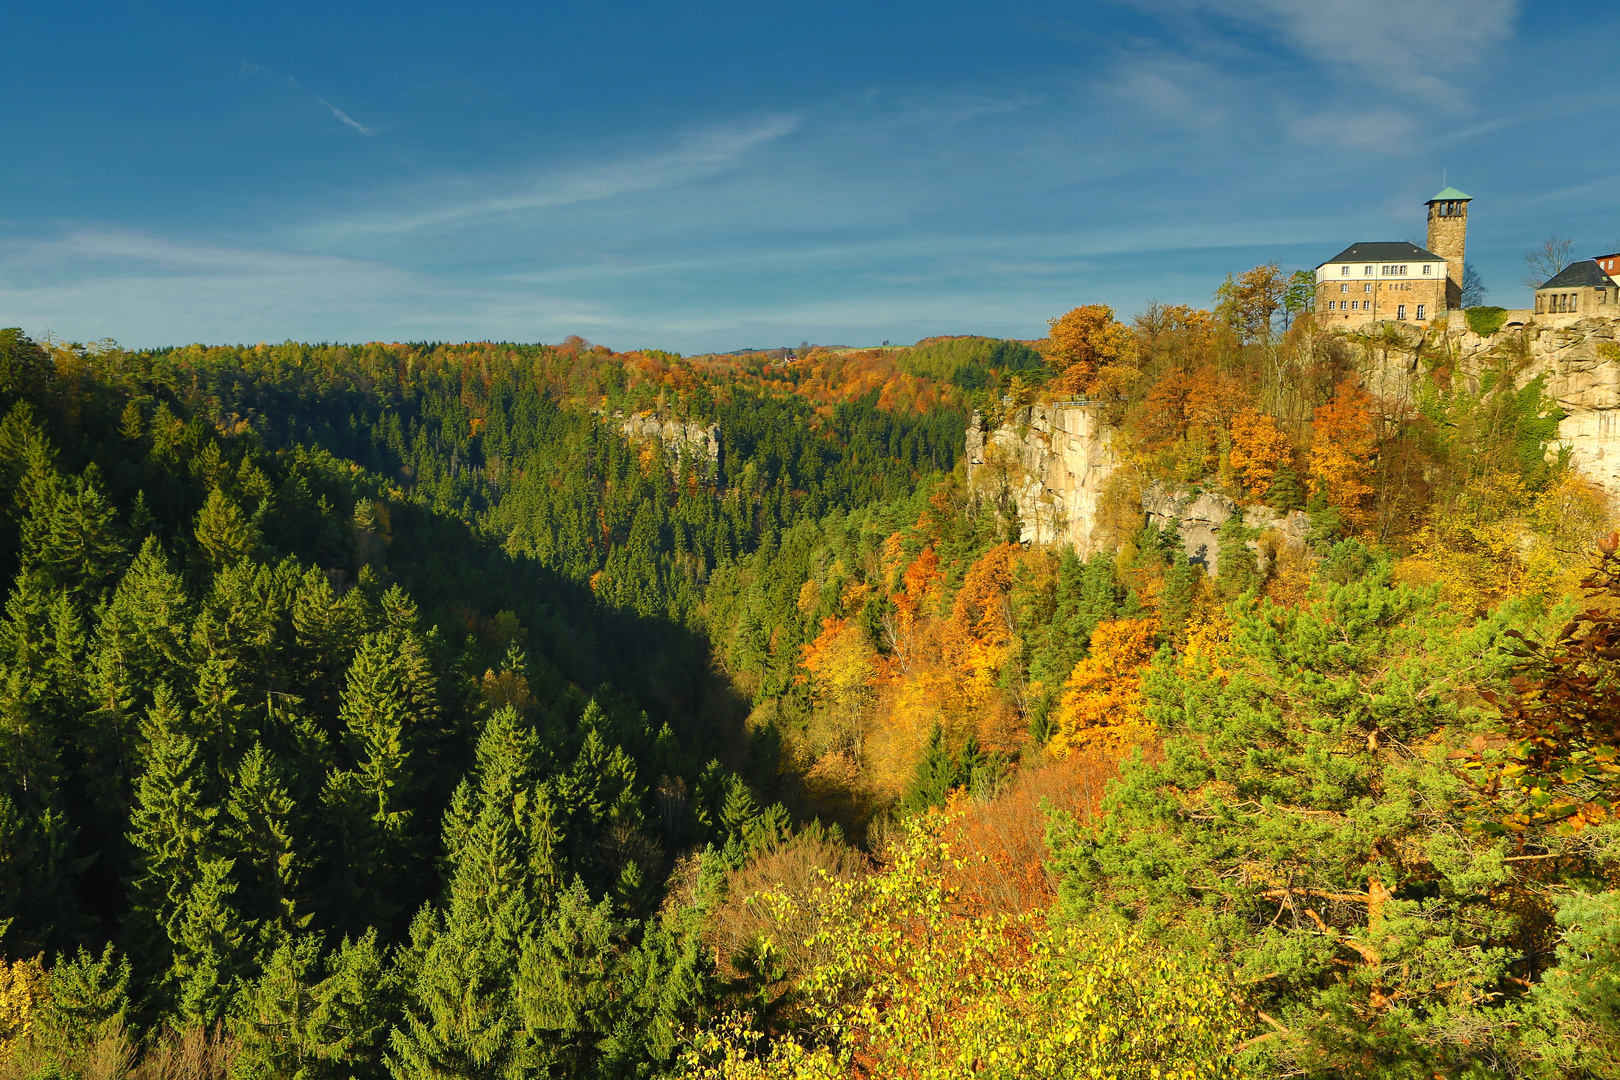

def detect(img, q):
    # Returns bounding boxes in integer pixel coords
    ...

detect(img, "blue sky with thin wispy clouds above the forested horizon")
[0,0,1620,353]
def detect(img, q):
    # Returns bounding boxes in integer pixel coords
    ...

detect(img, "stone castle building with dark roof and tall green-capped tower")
[1315,188,1473,325]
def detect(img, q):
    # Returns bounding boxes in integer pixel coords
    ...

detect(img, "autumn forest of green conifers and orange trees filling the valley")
[0,275,1620,1080]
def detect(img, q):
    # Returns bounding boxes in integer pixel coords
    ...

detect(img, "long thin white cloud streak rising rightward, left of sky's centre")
[314,115,800,243]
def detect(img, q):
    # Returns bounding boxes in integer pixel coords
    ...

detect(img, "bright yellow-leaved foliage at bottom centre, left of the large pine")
[679,821,1252,1080]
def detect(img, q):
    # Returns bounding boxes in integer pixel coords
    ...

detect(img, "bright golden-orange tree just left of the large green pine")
[1051,617,1158,756]
